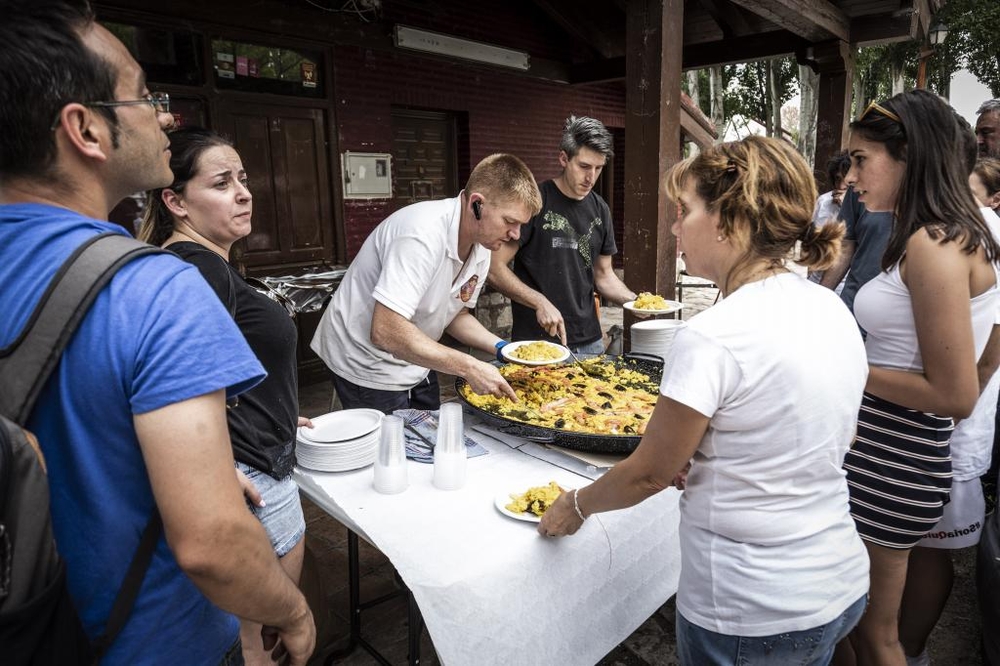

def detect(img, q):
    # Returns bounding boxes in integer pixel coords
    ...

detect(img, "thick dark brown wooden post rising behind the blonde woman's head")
[624,0,684,306]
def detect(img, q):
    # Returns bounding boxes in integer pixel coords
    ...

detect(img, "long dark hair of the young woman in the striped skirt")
[851,90,1000,270]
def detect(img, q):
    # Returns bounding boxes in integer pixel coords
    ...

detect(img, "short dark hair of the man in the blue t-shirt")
[0,0,117,181]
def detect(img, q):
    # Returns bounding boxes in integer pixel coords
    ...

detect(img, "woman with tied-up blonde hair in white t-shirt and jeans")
[539,137,868,666]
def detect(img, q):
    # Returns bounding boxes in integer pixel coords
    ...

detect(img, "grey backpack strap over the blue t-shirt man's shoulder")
[0,232,162,425]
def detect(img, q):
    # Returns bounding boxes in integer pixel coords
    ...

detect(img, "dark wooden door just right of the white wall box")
[392,109,459,210]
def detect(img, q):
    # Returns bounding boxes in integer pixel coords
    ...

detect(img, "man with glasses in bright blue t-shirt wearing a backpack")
[0,0,315,664]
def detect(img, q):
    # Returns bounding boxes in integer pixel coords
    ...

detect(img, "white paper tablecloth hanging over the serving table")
[295,426,680,665]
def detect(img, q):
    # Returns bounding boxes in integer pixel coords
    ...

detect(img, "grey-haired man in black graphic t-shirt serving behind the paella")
[489,116,635,354]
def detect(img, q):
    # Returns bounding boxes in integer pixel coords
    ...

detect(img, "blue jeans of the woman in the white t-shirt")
[677,595,868,666]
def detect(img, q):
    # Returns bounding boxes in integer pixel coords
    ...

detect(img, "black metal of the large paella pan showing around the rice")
[455,354,663,453]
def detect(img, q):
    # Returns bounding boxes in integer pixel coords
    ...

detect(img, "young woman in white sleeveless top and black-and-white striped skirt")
[844,90,1000,665]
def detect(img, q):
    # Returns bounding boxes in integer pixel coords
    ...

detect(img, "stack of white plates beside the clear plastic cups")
[295,409,382,472]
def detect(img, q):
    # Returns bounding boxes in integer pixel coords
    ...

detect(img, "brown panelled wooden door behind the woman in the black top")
[219,101,336,273]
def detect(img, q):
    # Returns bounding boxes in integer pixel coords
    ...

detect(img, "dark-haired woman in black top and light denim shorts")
[139,127,311,664]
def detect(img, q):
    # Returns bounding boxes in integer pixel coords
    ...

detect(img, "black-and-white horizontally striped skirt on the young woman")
[844,393,953,549]
